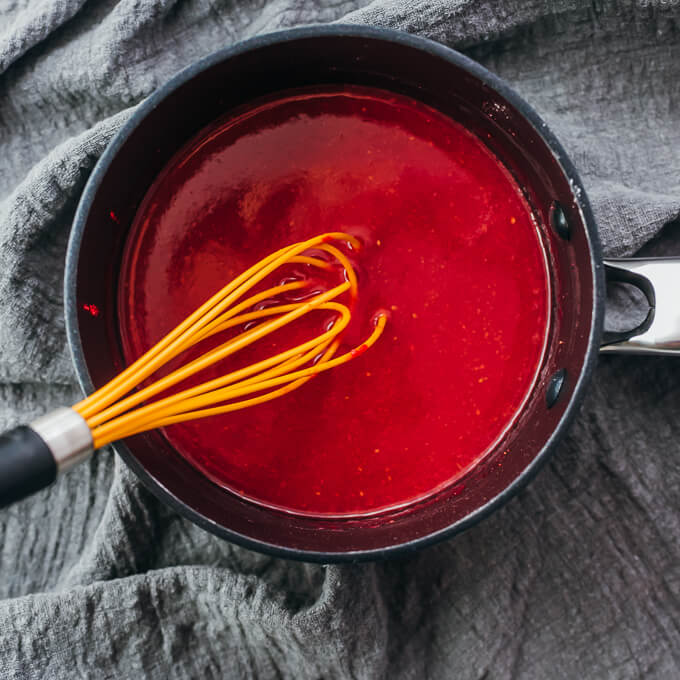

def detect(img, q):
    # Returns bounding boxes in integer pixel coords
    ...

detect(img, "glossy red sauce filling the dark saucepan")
[119,87,549,515]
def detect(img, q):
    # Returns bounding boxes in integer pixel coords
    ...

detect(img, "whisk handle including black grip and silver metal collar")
[0,408,92,508]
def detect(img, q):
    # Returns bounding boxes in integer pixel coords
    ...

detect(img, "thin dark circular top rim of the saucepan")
[64,24,605,563]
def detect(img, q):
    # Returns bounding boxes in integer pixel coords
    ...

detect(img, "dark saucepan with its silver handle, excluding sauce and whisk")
[54,26,680,562]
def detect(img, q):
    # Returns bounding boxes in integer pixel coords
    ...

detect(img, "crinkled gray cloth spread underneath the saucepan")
[0,0,680,680]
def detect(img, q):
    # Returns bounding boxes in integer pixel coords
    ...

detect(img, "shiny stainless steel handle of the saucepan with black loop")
[600,257,680,356]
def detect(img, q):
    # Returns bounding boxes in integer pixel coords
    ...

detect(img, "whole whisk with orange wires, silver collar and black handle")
[0,232,387,507]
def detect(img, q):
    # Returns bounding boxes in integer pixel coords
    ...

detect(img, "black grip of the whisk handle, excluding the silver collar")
[0,425,57,508]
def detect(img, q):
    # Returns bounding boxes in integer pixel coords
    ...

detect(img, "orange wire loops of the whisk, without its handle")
[73,232,387,448]
